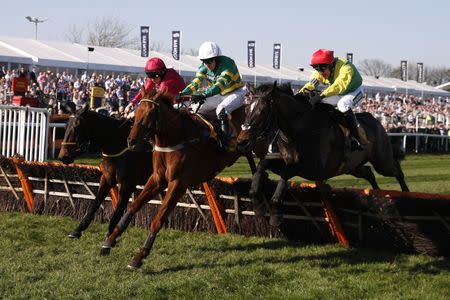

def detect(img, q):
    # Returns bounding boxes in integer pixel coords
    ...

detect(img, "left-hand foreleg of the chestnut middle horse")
[100,175,162,255]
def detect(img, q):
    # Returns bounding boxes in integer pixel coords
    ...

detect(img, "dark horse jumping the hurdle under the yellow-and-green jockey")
[238,83,408,214]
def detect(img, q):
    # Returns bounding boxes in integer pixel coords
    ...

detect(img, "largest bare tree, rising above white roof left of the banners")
[87,17,133,48]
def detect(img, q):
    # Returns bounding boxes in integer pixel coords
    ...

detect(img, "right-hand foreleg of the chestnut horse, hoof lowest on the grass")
[128,179,186,269]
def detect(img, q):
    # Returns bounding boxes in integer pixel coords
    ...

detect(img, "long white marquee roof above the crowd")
[0,36,450,97]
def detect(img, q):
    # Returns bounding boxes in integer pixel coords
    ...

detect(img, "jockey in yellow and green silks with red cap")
[299,49,363,150]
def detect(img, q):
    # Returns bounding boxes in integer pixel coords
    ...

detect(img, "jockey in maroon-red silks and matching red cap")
[125,57,186,113]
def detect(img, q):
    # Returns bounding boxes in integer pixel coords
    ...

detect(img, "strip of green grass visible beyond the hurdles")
[70,154,450,194]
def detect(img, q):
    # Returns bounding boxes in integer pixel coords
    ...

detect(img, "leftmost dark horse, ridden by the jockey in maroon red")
[58,106,152,238]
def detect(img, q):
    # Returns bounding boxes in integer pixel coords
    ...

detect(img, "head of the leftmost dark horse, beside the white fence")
[58,105,89,164]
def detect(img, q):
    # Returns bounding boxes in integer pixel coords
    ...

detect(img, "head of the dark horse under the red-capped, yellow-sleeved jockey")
[237,82,278,157]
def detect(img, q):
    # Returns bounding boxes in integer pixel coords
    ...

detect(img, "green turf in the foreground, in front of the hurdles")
[0,213,450,299]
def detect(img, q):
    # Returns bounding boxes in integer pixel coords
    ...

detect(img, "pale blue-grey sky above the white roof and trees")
[0,0,450,67]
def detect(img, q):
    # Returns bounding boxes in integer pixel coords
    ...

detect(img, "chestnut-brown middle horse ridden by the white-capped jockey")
[99,92,255,268]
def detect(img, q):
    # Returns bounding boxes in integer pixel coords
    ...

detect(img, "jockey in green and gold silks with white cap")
[180,42,247,150]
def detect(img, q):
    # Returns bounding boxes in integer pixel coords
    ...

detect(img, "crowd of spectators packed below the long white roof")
[0,66,450,135]
